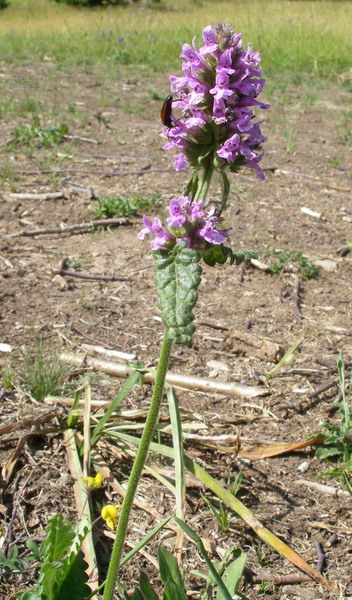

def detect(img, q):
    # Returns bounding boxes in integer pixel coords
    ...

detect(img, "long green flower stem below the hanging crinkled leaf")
[103,329,172,600]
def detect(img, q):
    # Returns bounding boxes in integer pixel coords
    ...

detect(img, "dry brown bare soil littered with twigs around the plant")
[0,63,352,600]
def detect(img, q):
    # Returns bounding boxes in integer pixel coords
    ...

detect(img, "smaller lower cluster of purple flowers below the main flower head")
[138,196,229,250]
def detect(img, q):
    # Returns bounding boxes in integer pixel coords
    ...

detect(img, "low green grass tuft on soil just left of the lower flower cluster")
[92,194,158,219]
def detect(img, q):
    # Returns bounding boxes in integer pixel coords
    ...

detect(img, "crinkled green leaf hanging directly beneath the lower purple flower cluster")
[154,242,202,346]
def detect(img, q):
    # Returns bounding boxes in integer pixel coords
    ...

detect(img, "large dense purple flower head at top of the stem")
[163,24,269,179]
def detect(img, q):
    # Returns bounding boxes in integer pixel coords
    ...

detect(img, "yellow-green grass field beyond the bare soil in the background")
[0,0,352,85]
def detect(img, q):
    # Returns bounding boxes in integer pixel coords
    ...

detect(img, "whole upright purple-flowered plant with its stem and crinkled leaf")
[103,24,268,600]
